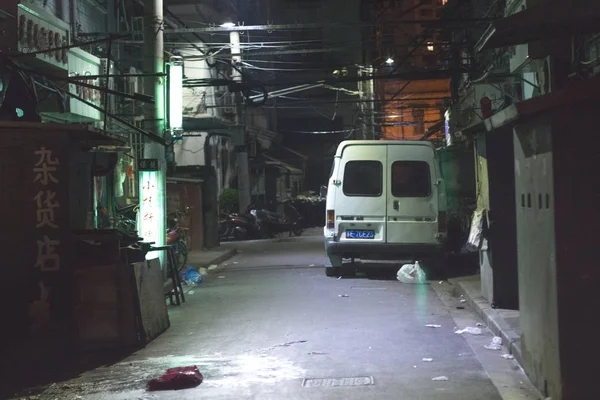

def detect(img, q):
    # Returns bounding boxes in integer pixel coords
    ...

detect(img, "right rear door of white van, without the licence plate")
[386,143,438,244]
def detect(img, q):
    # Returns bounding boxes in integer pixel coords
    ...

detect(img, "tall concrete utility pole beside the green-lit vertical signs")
[140,0,167,268]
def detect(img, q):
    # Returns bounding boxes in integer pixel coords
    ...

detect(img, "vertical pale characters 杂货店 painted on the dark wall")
[33,146,60,272]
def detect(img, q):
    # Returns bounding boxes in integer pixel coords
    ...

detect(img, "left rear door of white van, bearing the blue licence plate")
[335,144,387,243]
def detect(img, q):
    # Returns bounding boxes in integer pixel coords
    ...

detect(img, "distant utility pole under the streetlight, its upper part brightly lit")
[229,31,251,213]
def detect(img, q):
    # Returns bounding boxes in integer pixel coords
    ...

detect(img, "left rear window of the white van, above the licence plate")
[343,161,383,197]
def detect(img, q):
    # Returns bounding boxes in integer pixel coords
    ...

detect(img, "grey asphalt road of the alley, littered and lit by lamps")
[32,237,535,400]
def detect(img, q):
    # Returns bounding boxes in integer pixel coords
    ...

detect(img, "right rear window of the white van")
[392,161,431,197]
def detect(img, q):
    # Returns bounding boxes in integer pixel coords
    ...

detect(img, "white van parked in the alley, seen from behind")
[324,140,446,276]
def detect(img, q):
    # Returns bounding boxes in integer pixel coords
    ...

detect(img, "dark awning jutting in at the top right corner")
[475,0,600,52]
